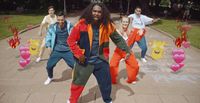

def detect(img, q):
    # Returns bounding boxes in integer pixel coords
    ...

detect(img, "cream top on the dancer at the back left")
[42,15,57,28]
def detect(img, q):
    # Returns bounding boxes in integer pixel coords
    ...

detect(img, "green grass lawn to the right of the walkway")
[153,19,200,48]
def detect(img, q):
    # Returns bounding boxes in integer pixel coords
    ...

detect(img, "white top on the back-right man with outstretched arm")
[128,14,153,29]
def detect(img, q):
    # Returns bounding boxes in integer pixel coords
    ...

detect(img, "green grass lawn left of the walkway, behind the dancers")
[0,14,44,40]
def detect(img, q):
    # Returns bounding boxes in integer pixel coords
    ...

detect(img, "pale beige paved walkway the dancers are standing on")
[0,14,200,103]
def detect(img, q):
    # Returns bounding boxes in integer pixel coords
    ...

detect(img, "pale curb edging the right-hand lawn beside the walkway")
[150,26,200,52]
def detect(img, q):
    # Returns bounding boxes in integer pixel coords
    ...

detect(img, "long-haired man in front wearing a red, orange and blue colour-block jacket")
[67,3,130,103]
